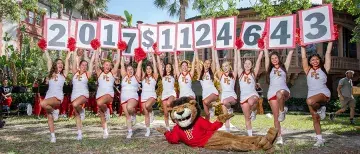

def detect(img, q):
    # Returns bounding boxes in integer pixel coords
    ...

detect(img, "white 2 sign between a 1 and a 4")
[193,19,214,49]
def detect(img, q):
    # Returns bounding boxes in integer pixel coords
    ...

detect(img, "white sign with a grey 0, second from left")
[75,20,98,49]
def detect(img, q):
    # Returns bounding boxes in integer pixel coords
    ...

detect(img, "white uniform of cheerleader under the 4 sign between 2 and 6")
[220,74,237,102]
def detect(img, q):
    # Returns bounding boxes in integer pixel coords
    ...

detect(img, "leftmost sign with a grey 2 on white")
[44,18,70,50]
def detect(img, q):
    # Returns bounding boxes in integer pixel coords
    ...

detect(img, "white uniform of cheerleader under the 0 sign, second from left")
[71,72,89,102]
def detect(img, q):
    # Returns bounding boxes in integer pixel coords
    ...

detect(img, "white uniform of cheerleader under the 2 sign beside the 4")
[200,72,219,100]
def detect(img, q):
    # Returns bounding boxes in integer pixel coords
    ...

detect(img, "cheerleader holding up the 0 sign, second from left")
[71,48,95,140]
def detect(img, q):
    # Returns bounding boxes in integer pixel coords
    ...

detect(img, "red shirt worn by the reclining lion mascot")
[164,117,223,147]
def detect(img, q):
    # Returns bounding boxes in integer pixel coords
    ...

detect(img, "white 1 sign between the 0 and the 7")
[99,19,120,49]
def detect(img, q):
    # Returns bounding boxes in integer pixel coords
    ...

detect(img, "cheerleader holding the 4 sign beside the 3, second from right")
[264,49,294,144]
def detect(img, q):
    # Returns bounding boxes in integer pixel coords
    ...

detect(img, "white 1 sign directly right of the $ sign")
[157,24,176,52]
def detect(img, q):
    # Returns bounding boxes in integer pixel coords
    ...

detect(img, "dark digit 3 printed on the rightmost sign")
[305,12,327,40]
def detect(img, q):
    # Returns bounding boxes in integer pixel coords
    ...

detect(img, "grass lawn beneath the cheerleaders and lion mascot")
[0,114,360,154]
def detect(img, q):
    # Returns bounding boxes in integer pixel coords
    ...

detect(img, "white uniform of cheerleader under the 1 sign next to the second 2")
[178,73,195,98]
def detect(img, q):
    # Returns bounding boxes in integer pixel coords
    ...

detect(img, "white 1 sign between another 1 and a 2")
[176,22,194,51]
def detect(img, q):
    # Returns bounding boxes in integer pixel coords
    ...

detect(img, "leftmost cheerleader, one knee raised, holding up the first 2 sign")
[40,50,71,143]
